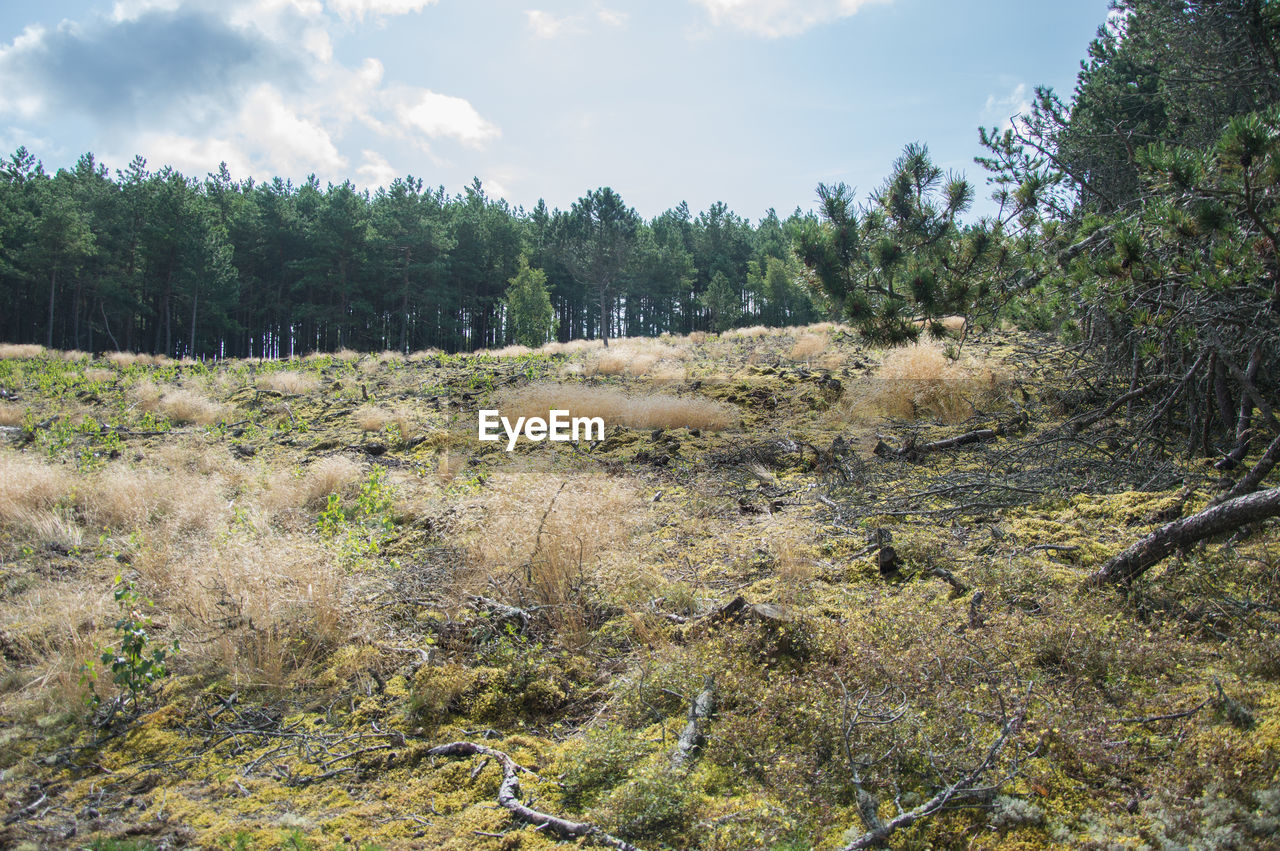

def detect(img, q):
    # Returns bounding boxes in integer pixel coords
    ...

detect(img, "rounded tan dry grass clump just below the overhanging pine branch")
[846,343,1007,422]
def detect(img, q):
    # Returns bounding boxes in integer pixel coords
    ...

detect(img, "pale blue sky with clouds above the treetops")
[0,0,1107,220]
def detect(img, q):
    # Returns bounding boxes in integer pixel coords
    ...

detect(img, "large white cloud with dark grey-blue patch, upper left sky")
[0,0,500,186]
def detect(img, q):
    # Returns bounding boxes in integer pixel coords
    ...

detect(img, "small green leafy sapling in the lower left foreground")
[84,576,179,710]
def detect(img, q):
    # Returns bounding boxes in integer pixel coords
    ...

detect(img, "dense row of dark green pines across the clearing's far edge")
[0,156,826,357]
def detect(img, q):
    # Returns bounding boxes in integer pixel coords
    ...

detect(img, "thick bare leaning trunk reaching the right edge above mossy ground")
[1087,488,1280,586]
